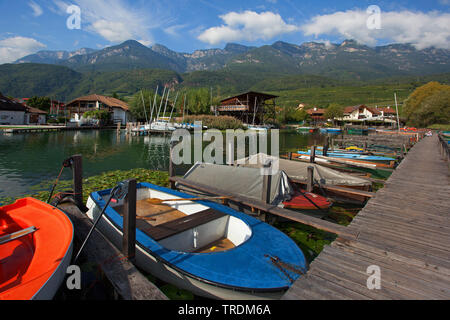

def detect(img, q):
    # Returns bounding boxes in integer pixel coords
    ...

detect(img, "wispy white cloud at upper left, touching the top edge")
[53,0,164,44]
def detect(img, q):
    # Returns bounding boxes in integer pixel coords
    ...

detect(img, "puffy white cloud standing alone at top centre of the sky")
[198,11,299,45]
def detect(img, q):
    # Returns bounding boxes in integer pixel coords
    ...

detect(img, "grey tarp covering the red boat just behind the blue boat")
[177,163,295,205]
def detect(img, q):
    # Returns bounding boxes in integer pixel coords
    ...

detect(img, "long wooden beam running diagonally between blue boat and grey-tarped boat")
[170,177,358,241]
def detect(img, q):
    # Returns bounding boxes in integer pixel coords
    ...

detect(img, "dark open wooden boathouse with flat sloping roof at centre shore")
[213,91,278,125]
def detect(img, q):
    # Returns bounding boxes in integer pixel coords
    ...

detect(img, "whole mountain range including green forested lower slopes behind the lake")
[0,40,450,107]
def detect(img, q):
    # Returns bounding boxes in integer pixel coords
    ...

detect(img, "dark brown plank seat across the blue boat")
[136,209,226,241]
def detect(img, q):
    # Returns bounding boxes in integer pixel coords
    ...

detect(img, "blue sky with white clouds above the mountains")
[0,0,450,64]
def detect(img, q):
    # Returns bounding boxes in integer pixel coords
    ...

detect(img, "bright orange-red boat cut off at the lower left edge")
[0,198,74,300]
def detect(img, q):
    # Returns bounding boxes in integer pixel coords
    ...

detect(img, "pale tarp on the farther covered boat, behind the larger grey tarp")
[236,153,372,187]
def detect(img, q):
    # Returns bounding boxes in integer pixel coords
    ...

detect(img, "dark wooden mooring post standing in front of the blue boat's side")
[122,179,137,261]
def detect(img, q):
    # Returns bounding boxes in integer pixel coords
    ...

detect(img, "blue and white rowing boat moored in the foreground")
[87,183,307,300]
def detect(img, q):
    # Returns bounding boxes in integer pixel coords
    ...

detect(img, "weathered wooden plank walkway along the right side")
[283,136,450,300]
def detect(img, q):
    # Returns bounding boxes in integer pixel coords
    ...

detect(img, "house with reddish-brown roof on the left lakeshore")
[66,94,131,124]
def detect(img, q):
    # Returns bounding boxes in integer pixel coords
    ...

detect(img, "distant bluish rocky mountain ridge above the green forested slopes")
[15,40,450,81]
